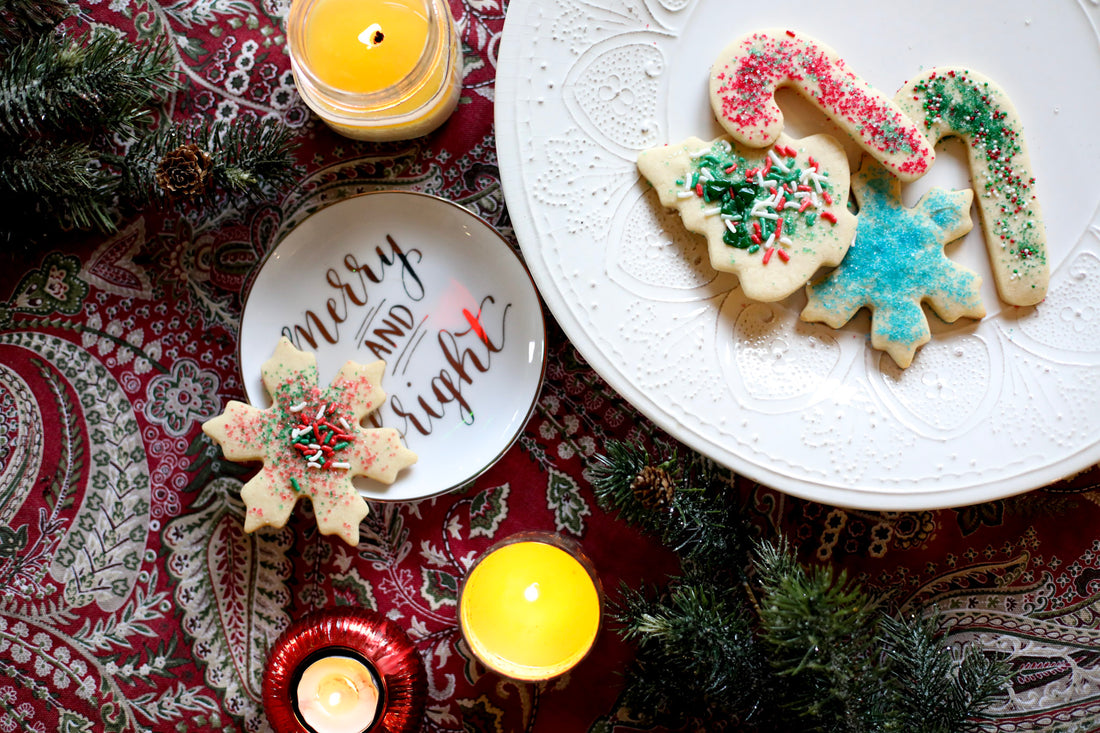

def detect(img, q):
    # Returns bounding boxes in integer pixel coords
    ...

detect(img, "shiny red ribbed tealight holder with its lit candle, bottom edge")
[263,608,427,733]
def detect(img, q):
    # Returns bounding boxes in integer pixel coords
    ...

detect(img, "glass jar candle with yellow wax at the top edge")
[286,0,462,141]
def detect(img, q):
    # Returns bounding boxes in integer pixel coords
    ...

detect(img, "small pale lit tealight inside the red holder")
[296,656,380,733]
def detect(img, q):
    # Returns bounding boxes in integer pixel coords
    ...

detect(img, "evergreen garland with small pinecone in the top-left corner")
[0,0,295,243]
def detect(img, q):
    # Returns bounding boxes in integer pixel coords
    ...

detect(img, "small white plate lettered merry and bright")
[240,192,546,501]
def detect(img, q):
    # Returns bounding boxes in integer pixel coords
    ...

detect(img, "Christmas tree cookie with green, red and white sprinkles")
[638,134,856,302]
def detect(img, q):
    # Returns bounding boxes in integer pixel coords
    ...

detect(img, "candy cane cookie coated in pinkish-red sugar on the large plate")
[710,29,935,180]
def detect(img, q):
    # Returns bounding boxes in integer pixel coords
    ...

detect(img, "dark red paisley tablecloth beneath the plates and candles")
[0,0,1100,733]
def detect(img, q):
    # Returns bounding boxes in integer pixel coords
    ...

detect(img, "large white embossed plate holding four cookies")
[496,0,1100,510]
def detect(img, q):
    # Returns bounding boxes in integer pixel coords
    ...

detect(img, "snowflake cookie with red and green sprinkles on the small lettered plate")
[202,338,417,546]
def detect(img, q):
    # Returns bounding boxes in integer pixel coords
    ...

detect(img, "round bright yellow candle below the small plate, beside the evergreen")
[459,532,603,681]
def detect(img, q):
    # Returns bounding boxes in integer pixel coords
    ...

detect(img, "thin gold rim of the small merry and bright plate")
[235,188,549,503]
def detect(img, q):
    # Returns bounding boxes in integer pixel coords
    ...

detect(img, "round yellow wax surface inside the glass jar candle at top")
[305,0,428,94]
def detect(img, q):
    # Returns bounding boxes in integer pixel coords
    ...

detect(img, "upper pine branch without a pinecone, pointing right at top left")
[0,28,178,140]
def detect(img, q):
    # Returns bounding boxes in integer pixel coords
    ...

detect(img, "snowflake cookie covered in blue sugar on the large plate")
[802,155,986,369]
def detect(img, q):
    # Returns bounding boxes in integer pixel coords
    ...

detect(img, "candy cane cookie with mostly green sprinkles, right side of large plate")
[894,66,1051,306]
